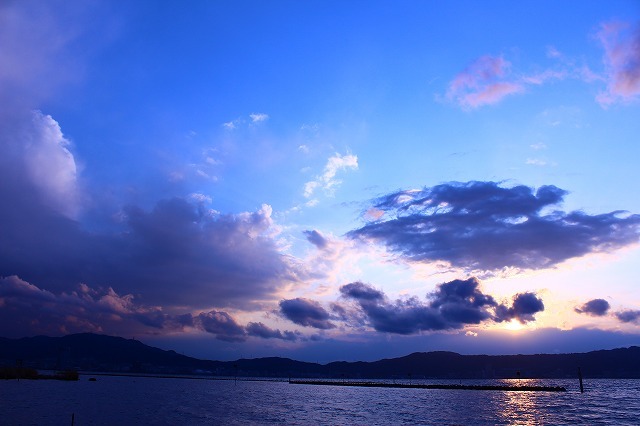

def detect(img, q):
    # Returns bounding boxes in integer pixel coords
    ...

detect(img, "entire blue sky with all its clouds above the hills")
[0,0,640,362]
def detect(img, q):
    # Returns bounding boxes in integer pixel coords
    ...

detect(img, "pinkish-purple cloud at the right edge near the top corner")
[596,22,640,107]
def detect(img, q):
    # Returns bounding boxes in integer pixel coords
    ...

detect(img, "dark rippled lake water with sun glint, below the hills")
[0,376,640,426]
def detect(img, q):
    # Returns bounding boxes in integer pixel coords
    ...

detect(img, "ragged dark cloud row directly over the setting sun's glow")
[334,277,544,334]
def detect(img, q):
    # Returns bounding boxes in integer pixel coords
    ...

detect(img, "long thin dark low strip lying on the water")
[289,380,567,392]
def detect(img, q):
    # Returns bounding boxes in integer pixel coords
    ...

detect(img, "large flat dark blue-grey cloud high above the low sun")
[347,181,640,271]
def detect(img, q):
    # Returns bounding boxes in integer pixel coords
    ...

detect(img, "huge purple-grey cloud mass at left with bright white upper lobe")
[0,111,305,309]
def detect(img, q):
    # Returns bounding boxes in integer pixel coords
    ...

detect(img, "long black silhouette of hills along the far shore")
[0,333,640,379]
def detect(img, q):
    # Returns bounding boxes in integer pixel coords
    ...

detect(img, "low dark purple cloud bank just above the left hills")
[0,276,304,342]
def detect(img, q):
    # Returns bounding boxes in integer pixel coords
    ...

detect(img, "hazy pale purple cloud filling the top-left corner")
[0,0,99,110]
